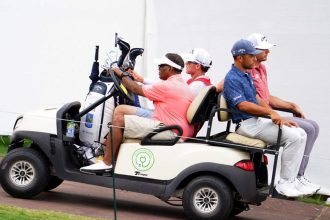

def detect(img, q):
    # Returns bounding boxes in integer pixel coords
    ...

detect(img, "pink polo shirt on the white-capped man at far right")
[248,63,269,104]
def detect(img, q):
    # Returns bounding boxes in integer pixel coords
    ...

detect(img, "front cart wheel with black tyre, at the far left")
[0,148,49,198]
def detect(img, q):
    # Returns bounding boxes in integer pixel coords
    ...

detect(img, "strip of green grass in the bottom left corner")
[0,205,101,220]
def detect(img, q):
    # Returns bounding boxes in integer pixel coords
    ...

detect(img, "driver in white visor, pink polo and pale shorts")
[80,53,194,172]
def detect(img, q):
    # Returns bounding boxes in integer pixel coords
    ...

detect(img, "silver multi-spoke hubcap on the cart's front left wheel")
[9,161,35,187]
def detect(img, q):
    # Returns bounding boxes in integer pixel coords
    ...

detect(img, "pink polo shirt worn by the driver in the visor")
[142,74,194,140]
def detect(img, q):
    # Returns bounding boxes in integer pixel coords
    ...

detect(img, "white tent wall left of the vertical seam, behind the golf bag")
[0,0,145,133]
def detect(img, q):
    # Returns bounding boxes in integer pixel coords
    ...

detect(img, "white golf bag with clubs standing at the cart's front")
[76,34,144,164]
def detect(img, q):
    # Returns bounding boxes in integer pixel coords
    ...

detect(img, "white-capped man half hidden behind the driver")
[182,48,212,96]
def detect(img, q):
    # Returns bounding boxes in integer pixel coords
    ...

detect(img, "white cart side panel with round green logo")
[115,142,250,181]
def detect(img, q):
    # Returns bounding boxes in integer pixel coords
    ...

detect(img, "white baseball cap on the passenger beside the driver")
[182,48,212,67]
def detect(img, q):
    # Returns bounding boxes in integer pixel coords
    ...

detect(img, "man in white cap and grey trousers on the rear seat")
[248,33,320,194]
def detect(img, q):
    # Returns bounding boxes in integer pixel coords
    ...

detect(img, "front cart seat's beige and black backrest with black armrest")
[141,86,217,145]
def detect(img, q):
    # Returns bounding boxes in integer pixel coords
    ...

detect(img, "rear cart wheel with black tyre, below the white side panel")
[183,176,233,220]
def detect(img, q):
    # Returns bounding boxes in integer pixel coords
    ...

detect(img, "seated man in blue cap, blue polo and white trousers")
[223,39,306,197]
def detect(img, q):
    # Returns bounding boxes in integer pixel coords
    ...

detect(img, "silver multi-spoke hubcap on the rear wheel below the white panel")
[193,187,219,213]
